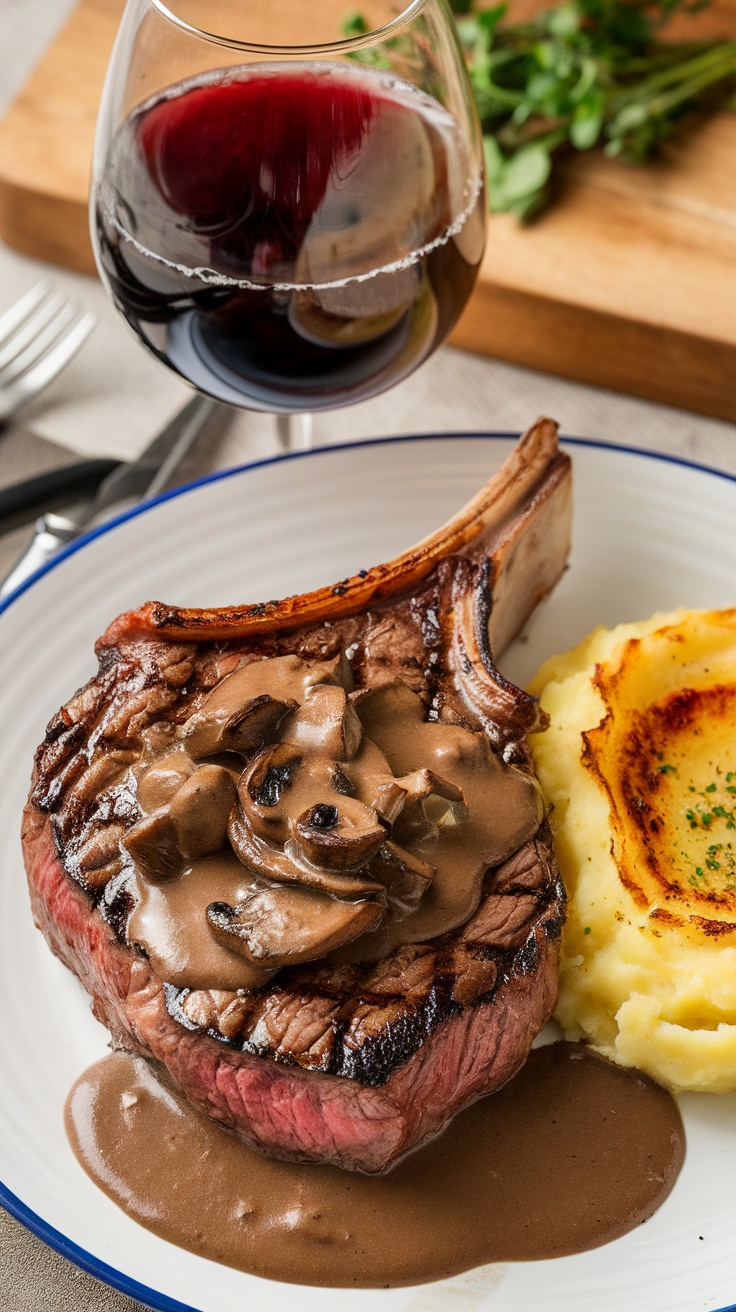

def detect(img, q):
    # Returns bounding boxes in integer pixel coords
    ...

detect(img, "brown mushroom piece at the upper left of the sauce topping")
[181,676,296,758]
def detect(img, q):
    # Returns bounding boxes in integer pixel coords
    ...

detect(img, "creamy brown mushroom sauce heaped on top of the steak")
[122,656,542,991]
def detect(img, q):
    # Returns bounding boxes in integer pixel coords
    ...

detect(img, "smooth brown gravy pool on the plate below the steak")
[66,1043,685,1288]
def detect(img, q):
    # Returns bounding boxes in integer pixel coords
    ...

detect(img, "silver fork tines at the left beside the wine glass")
[0,279,97,424]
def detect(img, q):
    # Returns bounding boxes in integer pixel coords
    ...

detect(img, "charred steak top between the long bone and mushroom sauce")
[31,562,511,921]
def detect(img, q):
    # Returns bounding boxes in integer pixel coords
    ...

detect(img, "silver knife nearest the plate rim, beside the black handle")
[0,396,220,601]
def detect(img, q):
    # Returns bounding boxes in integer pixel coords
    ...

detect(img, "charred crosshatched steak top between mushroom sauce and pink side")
[165,828,556,1085]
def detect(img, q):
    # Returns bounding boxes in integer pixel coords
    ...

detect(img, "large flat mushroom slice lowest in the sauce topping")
[207,884,384,968]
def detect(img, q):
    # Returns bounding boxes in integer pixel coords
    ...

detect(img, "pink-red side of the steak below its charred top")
[24,807,563,1172]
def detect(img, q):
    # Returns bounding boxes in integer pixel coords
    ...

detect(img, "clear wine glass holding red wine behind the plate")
[92,0,485,430]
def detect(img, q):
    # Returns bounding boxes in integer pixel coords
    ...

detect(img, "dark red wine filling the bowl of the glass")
[96,64,484,411]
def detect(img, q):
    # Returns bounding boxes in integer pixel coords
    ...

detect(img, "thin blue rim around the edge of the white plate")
[0,430,736,1312]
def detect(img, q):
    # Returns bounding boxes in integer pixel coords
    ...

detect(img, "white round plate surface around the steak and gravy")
[0,434,736,1312]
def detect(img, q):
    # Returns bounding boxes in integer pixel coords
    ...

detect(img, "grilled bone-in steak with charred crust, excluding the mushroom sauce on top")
[24,421,569,1170]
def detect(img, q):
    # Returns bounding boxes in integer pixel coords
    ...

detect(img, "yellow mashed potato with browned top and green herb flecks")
[531,610,736,1093]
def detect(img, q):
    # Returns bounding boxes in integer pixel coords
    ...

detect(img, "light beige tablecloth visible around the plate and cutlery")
[0,0,736,1312]
